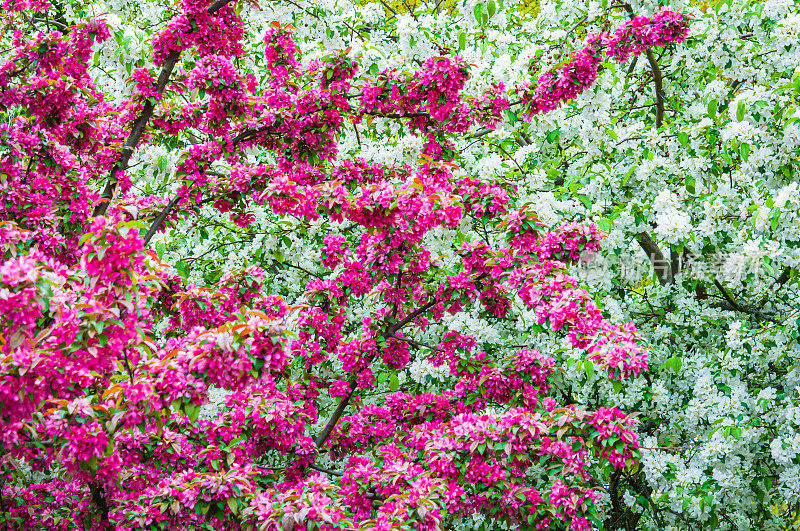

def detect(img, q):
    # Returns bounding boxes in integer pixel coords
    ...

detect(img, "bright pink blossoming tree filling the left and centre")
[0,0,688,530]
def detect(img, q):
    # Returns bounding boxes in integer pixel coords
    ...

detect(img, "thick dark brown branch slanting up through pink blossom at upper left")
[93,0,231,216]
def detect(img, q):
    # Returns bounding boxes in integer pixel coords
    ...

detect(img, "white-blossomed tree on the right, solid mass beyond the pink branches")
[432,1,800,529]
